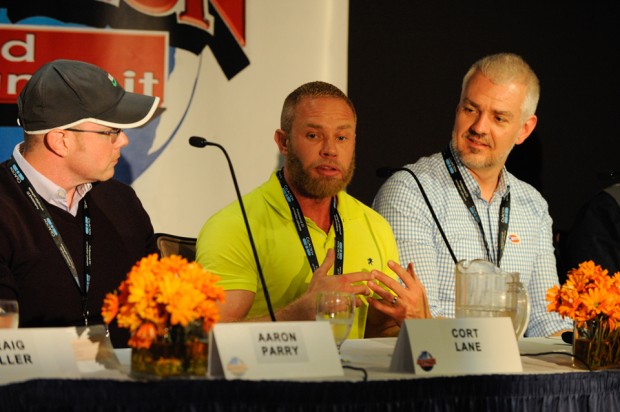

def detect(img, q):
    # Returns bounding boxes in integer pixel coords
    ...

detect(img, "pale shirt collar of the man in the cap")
[13,142,93,216]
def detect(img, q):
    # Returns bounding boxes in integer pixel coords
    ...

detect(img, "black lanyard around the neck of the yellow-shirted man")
[276,169,344,275]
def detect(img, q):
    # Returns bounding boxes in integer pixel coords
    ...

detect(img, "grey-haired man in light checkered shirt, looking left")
[373,53,572,336]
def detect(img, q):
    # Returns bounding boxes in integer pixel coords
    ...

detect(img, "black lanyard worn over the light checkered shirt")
[442,148,510,267]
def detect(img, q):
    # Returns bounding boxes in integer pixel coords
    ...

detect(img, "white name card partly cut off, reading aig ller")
[0,326,120,384]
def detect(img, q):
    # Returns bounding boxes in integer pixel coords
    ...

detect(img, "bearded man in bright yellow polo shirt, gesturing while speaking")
[196,82,429,338]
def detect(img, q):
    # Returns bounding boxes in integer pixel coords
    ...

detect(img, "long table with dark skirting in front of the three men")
[0,338,620,412]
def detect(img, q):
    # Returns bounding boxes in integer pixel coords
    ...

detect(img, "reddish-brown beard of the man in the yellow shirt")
[284,147,355,199]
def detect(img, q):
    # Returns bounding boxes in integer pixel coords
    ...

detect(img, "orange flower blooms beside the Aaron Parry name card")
[101,254,225,349]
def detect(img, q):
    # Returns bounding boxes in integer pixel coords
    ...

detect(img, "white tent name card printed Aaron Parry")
[208,321,344,380]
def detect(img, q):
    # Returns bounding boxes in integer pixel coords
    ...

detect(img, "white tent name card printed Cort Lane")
[390,317,523,375]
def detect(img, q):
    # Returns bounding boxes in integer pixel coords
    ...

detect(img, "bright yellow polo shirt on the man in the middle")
[196,173,398,338]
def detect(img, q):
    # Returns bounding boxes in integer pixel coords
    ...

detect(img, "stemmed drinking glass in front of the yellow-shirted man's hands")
[316,292,355,354]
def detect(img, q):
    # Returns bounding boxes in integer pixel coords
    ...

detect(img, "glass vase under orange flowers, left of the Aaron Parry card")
[131,322,208,379]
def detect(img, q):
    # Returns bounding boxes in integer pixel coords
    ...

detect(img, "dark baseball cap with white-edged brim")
[17,60,159,134]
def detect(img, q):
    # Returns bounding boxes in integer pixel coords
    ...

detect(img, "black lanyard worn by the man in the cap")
[8,156,92,325]
